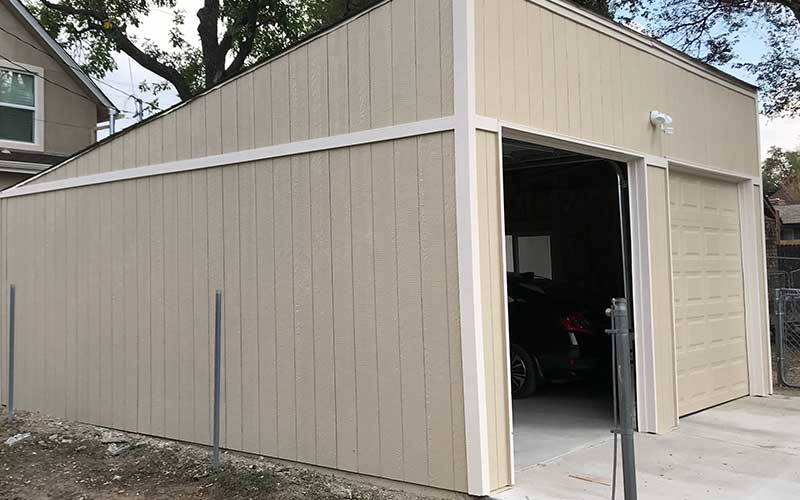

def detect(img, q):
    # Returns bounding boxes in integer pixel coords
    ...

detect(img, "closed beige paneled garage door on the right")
[670,171,748,416]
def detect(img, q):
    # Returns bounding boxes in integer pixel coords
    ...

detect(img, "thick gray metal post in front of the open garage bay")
[612,298,637,500]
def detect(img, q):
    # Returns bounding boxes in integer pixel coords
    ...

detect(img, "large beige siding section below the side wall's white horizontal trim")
[0,130,468,491]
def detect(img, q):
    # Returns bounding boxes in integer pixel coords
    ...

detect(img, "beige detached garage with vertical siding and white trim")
[0,0,772,495]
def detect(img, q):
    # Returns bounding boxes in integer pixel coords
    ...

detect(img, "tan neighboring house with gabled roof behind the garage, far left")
[0,0,116,189]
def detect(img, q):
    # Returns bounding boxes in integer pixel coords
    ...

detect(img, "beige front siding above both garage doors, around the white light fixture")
[475,0,759,175]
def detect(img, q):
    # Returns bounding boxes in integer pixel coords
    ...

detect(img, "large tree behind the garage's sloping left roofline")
[29,0,348,104]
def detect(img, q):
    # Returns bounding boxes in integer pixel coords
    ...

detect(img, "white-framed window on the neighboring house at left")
[0,68,42,149]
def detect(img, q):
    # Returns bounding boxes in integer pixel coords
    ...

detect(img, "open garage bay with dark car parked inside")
[503,139,629,470]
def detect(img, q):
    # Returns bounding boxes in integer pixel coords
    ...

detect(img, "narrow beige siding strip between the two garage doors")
[647,167,678,432]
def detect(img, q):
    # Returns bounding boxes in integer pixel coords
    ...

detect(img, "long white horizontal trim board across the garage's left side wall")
[0,116,455,198]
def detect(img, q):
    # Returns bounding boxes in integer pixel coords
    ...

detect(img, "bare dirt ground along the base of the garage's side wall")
[0,407,440,500]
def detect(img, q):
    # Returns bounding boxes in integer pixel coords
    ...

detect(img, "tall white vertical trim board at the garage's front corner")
[453,0,491,496]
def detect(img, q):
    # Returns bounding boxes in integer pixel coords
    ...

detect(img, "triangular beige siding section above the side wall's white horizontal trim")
[33,0,454,186]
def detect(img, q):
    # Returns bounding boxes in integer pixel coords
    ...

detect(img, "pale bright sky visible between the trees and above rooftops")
[101,0,800,158]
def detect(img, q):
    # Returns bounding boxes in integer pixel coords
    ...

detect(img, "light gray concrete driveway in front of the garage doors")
[497,396,800,500]
